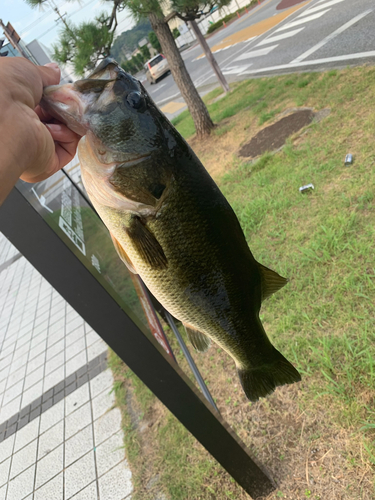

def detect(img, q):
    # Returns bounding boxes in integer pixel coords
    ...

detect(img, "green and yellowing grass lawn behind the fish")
[111,66,375,500]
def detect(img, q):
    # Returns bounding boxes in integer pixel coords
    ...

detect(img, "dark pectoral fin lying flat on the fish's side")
[126,215,168,269]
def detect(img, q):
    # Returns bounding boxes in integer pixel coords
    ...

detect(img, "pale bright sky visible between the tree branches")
[0,0,134,48]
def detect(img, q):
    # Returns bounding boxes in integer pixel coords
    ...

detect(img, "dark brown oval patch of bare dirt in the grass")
[238,109,314,158]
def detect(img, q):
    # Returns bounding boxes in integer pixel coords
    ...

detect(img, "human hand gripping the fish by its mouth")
[0,57,80,199]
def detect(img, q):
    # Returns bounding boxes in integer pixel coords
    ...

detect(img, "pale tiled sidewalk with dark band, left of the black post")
[0,233,133,500]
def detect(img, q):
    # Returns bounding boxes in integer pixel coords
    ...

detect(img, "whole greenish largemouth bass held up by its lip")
[42,59,301,401]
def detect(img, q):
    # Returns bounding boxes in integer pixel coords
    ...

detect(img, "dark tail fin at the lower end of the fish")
[238,348,301,401]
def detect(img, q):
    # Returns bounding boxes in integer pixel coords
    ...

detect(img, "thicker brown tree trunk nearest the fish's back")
[148,12,214,138]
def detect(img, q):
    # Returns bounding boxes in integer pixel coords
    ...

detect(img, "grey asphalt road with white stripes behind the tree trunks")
[146,0,375,117]
